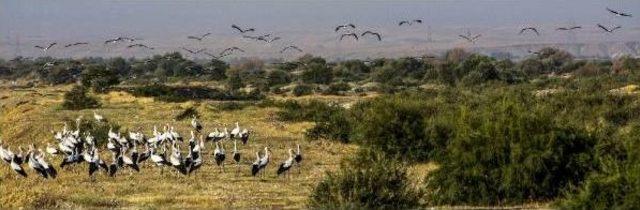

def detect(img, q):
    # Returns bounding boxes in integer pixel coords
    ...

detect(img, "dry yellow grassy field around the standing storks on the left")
[0,86,364,209]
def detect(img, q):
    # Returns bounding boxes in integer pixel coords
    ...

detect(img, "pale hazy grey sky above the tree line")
[0,0,640,57]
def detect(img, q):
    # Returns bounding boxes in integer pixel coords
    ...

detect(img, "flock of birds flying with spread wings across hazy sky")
[22,8,633,59]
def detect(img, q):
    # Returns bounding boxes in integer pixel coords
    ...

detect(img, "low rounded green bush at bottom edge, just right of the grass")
[309,150,421,209]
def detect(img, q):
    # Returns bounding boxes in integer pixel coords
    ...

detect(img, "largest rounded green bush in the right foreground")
[426,94,597,205]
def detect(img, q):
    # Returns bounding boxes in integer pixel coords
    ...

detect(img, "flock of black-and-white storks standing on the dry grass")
[0,112,302,179]
